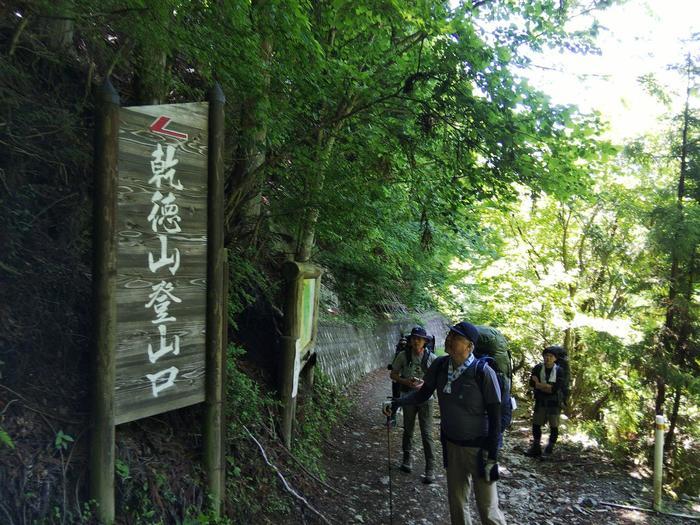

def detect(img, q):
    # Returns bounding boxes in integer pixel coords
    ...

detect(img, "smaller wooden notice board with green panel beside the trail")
[280,261,321,448]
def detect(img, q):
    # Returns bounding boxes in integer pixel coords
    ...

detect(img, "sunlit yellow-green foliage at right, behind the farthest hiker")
[446,47,700,492]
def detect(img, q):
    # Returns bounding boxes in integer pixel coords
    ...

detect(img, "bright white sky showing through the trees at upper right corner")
[524,0,700,140]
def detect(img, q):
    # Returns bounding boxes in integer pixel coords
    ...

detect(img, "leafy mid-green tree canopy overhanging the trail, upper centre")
[264,2,605,317]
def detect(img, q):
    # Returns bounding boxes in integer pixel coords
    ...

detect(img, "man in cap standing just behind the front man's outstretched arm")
[390,326,435,483]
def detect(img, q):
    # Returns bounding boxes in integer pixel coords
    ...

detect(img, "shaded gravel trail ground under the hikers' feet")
[302,369,698,525]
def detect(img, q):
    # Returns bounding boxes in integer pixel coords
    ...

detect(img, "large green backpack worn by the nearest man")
[474,325,514,431]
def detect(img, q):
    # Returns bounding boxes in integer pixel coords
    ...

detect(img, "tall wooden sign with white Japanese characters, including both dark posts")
[91,82,226,522]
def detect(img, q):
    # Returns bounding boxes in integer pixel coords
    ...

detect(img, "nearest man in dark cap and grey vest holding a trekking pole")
[392,322,506,525]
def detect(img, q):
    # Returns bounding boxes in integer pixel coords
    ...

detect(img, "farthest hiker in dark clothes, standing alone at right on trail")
[525,346,564,457]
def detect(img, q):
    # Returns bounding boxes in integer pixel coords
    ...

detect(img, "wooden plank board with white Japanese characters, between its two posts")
[114,102,208,424]
